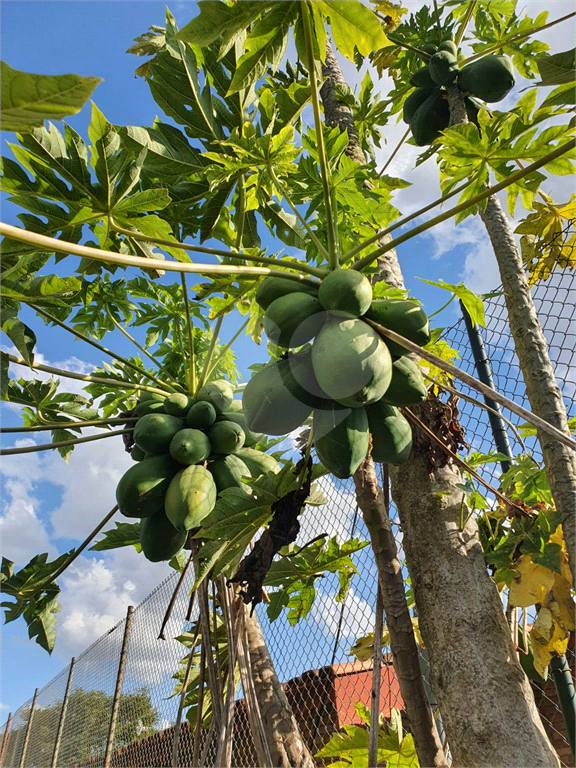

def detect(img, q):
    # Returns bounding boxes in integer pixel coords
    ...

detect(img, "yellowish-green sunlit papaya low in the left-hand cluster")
[164,464,216,531]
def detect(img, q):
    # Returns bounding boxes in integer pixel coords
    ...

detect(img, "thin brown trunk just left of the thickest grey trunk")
[354,456,447,766]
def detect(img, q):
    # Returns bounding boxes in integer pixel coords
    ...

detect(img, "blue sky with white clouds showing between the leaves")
[0,0,574,720]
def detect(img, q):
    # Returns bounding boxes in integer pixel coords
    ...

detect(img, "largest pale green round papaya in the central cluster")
[312,318,392,408]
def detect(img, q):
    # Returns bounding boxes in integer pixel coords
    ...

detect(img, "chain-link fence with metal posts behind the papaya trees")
[1,272,576,768]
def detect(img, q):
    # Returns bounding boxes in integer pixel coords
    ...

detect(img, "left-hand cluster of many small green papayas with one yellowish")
[116,379,280,562]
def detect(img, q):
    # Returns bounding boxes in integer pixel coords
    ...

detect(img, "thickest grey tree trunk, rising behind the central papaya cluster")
[322,42,559,766]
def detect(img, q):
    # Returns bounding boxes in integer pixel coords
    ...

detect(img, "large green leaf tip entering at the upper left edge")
[0,61,102,133]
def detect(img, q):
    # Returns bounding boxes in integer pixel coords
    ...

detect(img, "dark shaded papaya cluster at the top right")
[403,39,515,147]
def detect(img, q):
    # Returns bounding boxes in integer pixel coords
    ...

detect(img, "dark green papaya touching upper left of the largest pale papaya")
[264,293,326,349]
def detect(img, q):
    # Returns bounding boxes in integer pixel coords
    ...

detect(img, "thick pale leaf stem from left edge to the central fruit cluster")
[0,222,324,287]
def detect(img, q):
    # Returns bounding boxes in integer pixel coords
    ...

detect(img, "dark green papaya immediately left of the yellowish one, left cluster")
[116,455,181,517]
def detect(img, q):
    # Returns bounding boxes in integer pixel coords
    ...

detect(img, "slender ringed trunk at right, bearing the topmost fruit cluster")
[448,86,576,584]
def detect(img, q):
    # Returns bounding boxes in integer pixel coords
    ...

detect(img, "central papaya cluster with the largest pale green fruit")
[242,268,430,478]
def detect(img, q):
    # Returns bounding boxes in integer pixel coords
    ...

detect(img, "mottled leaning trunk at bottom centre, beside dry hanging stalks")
[246,611,314,768]
